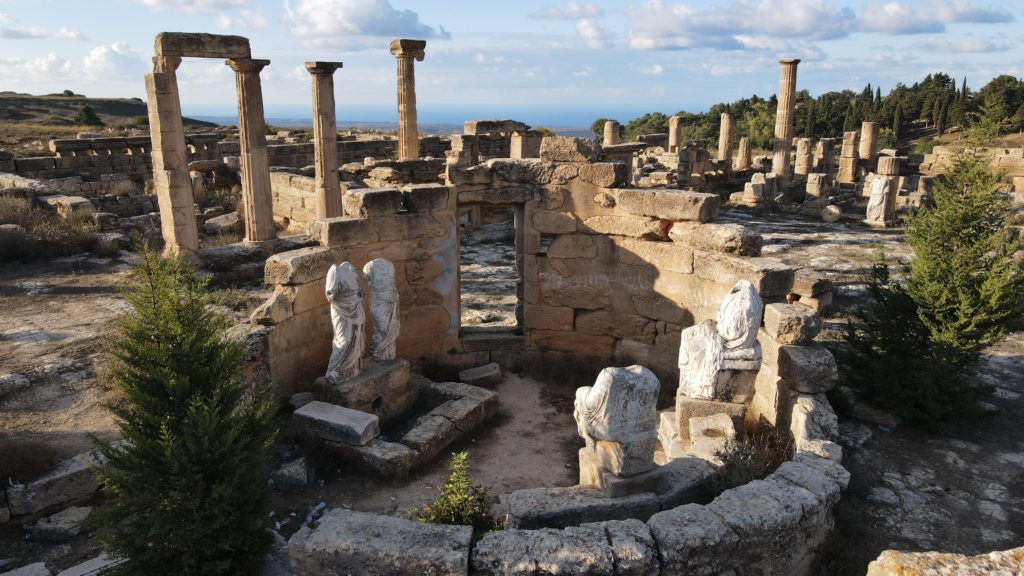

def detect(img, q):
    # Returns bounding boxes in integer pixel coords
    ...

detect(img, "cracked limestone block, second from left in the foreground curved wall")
[471,520,657,576]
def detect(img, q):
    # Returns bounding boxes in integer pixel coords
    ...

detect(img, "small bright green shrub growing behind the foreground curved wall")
[414,452,504,538]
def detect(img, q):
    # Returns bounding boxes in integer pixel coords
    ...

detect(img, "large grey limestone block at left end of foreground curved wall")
[288,508,473,576]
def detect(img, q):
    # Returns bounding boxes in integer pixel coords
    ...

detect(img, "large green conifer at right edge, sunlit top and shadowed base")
[840,154,1024,426]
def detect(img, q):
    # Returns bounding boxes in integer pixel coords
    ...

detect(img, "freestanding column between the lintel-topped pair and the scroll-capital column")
[306,61,343,218]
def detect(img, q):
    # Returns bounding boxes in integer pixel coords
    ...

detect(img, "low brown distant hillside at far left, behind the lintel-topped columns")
[0,91,216,128]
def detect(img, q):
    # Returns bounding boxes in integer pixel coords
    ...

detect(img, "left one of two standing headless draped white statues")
[327,262,366,382]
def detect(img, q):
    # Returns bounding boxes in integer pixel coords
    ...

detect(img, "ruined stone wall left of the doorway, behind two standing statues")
[256,181,459,395]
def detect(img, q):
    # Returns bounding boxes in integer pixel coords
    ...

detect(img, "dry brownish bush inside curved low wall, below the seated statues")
[710,425,793,496]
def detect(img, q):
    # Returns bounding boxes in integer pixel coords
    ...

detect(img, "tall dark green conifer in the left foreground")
[96,247,275,576]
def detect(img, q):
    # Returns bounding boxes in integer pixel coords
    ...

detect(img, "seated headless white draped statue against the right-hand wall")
[677,280,764,400]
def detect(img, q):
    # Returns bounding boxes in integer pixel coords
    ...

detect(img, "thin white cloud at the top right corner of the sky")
[861,0,1014,34]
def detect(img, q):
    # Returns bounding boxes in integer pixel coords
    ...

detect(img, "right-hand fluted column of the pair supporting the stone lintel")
[226,58,275,244]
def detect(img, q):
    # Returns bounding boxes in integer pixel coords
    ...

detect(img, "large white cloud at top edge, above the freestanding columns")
[285,0,452,46]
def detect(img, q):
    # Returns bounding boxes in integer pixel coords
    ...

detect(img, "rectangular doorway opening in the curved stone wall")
[459,205,523,333]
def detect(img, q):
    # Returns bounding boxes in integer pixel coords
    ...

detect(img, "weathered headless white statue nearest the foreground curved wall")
[572,366,662,477]
